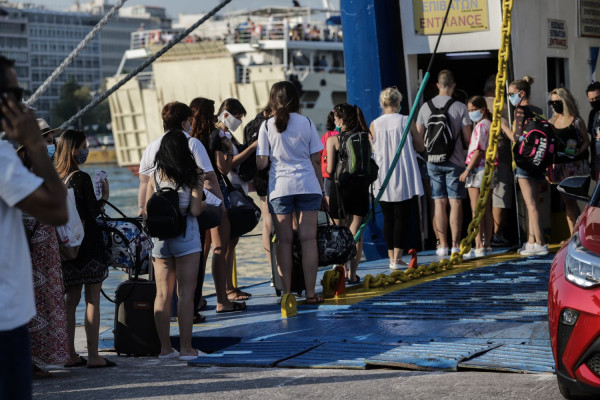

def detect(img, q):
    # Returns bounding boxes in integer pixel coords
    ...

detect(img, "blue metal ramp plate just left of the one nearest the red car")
[365,342,499,371]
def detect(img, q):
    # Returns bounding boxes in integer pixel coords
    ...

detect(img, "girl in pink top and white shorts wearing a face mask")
[459,96,497,257]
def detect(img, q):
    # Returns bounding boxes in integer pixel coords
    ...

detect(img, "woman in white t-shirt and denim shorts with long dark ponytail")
[256,81,323,304]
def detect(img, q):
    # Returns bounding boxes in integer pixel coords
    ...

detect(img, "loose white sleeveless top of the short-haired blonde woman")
[373,114,423,202]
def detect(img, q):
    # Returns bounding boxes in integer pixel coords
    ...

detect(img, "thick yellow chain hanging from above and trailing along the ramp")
[323,0,514,296]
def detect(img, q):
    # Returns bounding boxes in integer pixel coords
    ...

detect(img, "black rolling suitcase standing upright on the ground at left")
[113,262,160,356]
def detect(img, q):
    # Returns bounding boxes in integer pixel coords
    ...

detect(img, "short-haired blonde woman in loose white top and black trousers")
[370,87,423,269]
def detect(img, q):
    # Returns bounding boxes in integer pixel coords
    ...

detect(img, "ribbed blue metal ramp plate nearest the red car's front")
[458,343,554,373]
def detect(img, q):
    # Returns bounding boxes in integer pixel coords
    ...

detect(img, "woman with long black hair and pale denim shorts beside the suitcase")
[146,131,204,361]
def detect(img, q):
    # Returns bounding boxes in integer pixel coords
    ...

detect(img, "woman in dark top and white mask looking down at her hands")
[208,98,258,304]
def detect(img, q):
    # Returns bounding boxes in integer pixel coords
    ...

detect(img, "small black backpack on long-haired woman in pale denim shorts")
[146,174,186,240]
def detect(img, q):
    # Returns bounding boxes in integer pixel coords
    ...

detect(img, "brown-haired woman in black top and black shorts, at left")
[54,129,116,368]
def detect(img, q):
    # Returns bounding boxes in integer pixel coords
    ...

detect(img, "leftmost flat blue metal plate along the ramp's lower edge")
[188,341,320,368]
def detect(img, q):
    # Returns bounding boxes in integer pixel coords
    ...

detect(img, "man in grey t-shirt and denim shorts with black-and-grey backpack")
[417,69,471,256]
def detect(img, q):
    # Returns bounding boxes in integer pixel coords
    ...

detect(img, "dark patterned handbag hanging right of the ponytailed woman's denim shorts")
[317,213,356,267]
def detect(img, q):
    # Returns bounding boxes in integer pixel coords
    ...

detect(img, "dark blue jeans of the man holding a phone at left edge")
[0,325,33,399]
